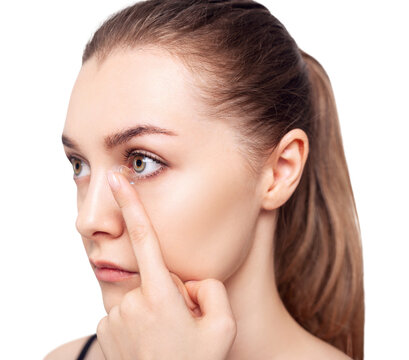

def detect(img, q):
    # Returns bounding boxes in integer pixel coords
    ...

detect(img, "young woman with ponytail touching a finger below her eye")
[46,0,364,360]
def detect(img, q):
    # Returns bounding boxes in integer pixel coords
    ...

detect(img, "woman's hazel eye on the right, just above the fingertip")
[124,149,166,179]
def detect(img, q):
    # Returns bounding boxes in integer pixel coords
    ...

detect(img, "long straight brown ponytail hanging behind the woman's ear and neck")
[275,50,364,360]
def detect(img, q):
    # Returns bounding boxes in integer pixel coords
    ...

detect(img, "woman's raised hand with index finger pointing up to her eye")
[97,173,237,360]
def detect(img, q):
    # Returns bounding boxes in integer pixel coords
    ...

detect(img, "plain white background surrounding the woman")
[0,0,409,359]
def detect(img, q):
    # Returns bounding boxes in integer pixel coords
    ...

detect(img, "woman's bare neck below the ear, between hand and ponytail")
[224,212,306,360]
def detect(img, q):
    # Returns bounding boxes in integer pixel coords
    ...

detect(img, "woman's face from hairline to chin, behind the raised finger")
[63,50,260,312]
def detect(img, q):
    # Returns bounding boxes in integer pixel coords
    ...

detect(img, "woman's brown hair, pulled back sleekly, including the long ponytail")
[82,0,364,360]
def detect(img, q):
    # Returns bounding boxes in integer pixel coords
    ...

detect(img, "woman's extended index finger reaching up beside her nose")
[108,171,174,296]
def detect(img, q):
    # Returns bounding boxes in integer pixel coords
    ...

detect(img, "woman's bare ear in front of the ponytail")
[262,129,309,210]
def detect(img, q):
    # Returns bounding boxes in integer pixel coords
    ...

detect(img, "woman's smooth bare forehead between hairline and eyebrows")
[63,49,221,143]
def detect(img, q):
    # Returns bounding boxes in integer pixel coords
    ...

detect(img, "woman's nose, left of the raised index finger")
[75,171,124,239]
